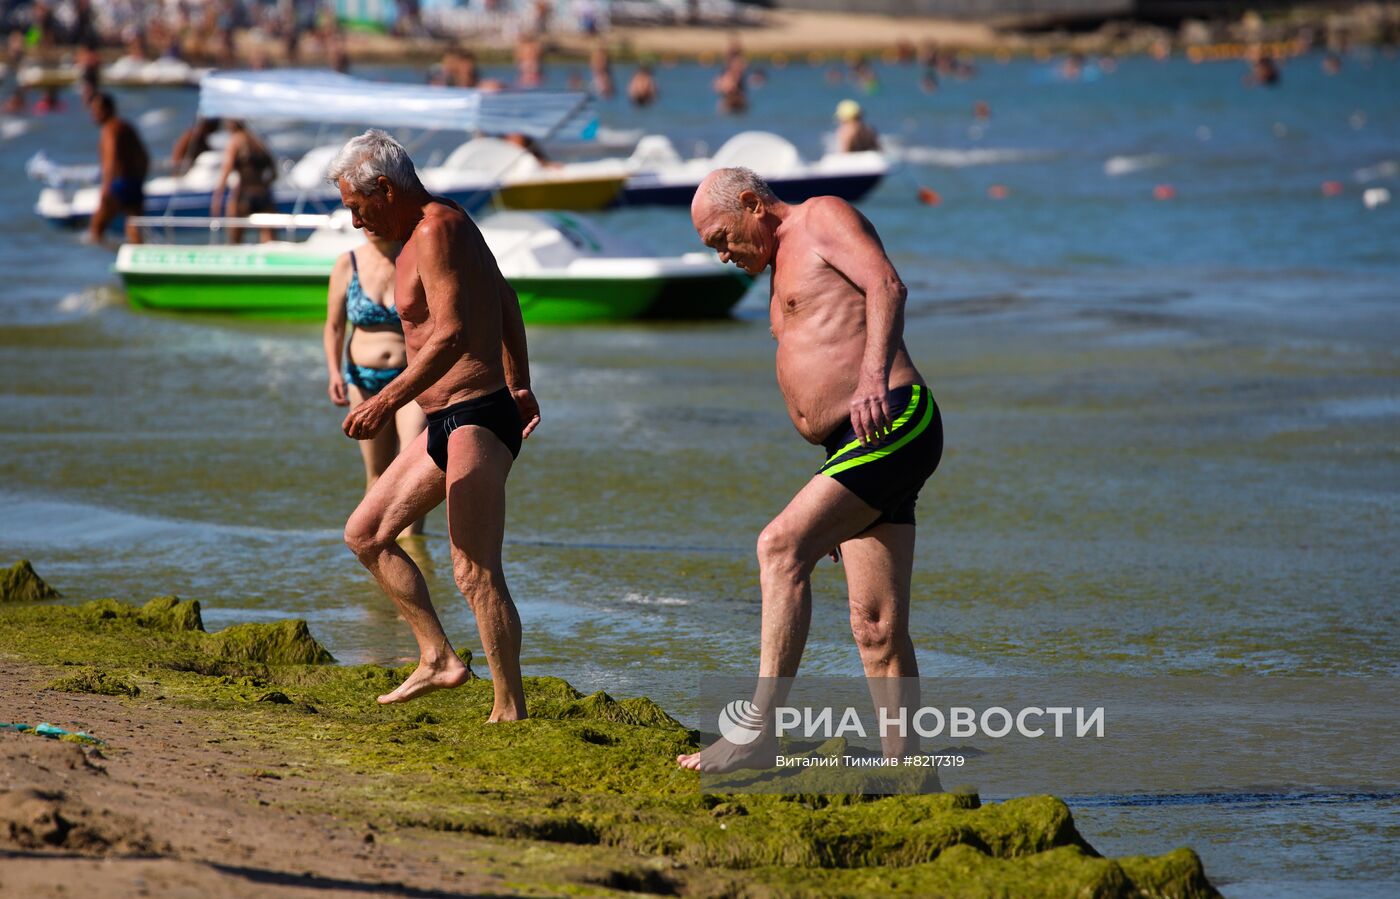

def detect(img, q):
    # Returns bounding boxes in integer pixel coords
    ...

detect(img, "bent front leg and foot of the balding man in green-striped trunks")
[676,475,879,772]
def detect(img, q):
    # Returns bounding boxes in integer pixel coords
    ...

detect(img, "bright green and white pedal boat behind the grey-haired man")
[115,211,753,323]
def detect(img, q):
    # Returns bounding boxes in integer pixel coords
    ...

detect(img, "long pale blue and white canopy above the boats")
[199,69,596,139]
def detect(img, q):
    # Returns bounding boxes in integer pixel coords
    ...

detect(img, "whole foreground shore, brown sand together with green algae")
[0,566,1218,896]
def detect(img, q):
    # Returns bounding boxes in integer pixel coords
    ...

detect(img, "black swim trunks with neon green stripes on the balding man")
[816,384,944,527]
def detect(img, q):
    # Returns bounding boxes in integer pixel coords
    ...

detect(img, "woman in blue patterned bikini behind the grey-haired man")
[325,231,427,536]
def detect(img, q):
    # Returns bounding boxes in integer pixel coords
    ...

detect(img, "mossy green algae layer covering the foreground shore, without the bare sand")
[0,562,1218,898]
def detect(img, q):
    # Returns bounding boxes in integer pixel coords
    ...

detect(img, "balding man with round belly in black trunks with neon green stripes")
[676,168,944,772]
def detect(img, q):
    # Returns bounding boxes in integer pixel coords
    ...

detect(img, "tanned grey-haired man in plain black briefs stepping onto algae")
[329,130,539,721]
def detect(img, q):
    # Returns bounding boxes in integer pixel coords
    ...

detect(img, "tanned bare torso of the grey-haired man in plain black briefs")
[393,197,514,413]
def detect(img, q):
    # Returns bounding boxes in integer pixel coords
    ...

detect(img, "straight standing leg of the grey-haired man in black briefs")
[447,424,525,721]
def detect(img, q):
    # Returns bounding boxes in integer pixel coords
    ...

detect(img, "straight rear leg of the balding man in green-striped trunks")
[841,524,918,758]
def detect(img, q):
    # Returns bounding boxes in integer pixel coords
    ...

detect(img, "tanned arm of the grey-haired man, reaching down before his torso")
[344,218,480,440]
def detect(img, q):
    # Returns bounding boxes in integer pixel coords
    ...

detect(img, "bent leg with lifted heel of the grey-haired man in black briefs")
[346,431,468,703]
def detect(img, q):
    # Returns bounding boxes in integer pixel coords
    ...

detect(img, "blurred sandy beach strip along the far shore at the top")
[13,4,1400,67]
